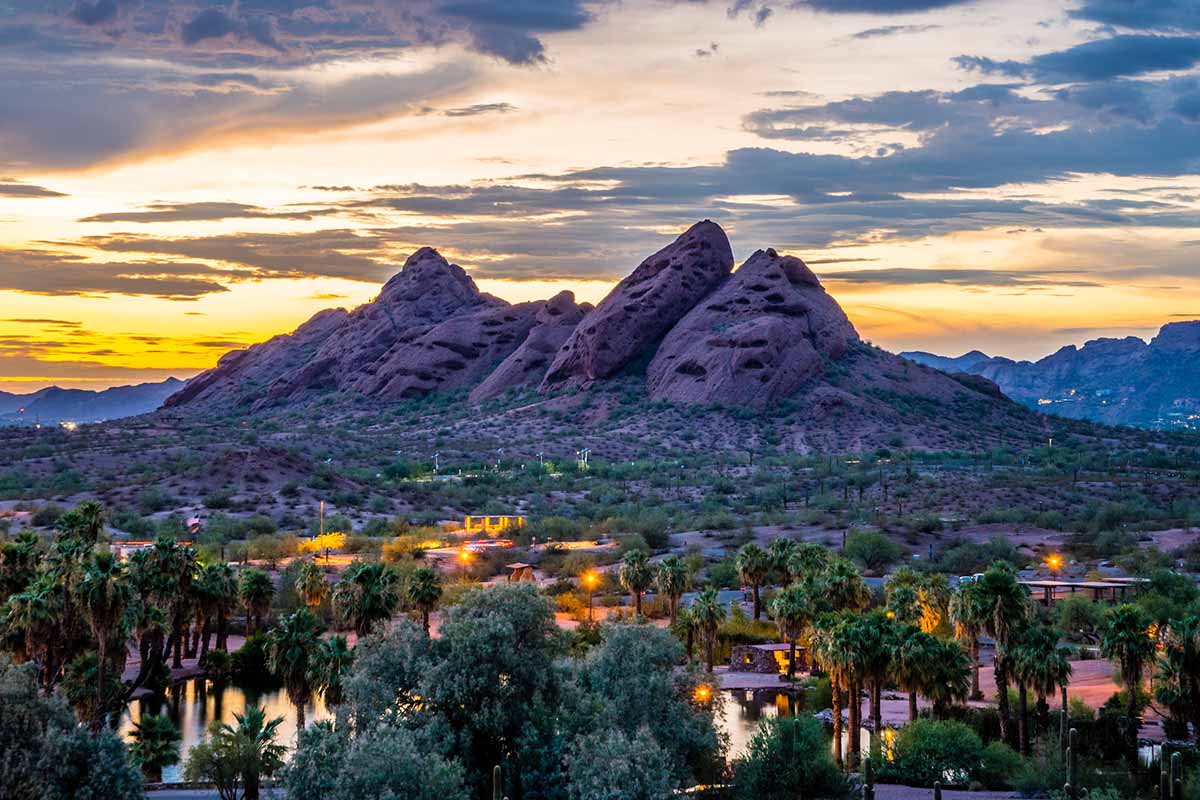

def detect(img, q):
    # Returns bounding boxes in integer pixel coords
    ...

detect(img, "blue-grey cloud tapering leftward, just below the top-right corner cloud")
[955,34,1200,84]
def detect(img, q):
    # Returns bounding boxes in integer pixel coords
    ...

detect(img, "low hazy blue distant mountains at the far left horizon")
[0,378,184,425]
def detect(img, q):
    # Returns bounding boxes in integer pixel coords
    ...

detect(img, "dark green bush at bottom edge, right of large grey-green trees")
[733,716,850,800]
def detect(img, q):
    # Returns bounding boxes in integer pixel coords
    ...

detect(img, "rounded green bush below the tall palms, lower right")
[880,720,983,787]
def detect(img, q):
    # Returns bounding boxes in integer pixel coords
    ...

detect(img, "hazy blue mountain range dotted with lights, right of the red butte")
[900,321,1200,429]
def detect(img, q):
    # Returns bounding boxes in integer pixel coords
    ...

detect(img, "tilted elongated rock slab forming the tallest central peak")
[541,219,733,391]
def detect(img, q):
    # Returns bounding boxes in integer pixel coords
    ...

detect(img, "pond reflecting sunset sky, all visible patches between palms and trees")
[119,679,870,782]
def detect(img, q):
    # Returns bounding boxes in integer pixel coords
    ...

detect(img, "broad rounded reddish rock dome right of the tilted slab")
[646,249,858,409]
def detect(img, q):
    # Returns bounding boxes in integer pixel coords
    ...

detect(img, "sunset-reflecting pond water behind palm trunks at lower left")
[119,679,331,782]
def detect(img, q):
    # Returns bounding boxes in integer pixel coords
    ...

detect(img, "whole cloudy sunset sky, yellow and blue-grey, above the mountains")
[0,0,1200,391]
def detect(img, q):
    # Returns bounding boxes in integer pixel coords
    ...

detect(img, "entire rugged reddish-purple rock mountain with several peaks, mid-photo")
[166,221,995,415]
